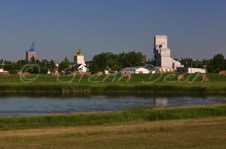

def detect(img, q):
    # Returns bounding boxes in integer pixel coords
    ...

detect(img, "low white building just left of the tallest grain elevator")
[121,67,150,74]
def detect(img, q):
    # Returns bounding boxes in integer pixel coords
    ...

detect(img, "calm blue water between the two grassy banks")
[0,96,226,116]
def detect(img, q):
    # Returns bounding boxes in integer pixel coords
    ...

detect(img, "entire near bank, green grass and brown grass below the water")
[0,104,226,149]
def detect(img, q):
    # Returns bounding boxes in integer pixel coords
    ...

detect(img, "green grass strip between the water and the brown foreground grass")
[0,104,226,130]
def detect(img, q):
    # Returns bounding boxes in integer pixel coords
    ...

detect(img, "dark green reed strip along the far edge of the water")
[0,84,226,96]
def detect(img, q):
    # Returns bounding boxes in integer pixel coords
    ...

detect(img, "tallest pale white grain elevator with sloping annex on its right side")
[154,35,181,70]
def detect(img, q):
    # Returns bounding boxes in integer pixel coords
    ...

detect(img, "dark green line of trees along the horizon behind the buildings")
[0,51,226,74]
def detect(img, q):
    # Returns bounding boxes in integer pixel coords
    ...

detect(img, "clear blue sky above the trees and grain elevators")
[0,0,226,62]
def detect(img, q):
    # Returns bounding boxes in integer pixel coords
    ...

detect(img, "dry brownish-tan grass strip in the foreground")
[0,117,226,149]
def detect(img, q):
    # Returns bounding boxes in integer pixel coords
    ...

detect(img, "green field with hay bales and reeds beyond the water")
[0,73,226,94]
